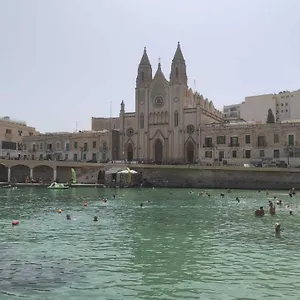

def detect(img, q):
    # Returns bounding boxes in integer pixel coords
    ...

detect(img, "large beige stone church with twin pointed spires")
[92,43,223,164]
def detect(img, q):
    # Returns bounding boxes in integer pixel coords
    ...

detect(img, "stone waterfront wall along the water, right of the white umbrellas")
[134,166,300,189]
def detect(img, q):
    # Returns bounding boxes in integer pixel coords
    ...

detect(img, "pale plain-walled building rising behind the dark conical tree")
[239,90,300,123]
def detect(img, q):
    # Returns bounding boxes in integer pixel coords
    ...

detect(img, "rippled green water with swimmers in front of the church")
[0,188,300,300]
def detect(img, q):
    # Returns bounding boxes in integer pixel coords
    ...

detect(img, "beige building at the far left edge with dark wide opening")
[0,117,37,159]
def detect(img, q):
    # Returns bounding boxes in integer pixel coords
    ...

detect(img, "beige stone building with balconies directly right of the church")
[199,123,300,166]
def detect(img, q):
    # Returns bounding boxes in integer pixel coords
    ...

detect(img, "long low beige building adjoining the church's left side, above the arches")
[23,130,120,162]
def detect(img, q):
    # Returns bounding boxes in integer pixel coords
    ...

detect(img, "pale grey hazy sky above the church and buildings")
[0,0,300,132]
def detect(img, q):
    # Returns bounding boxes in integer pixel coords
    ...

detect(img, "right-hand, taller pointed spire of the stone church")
[170,42,187,85]
